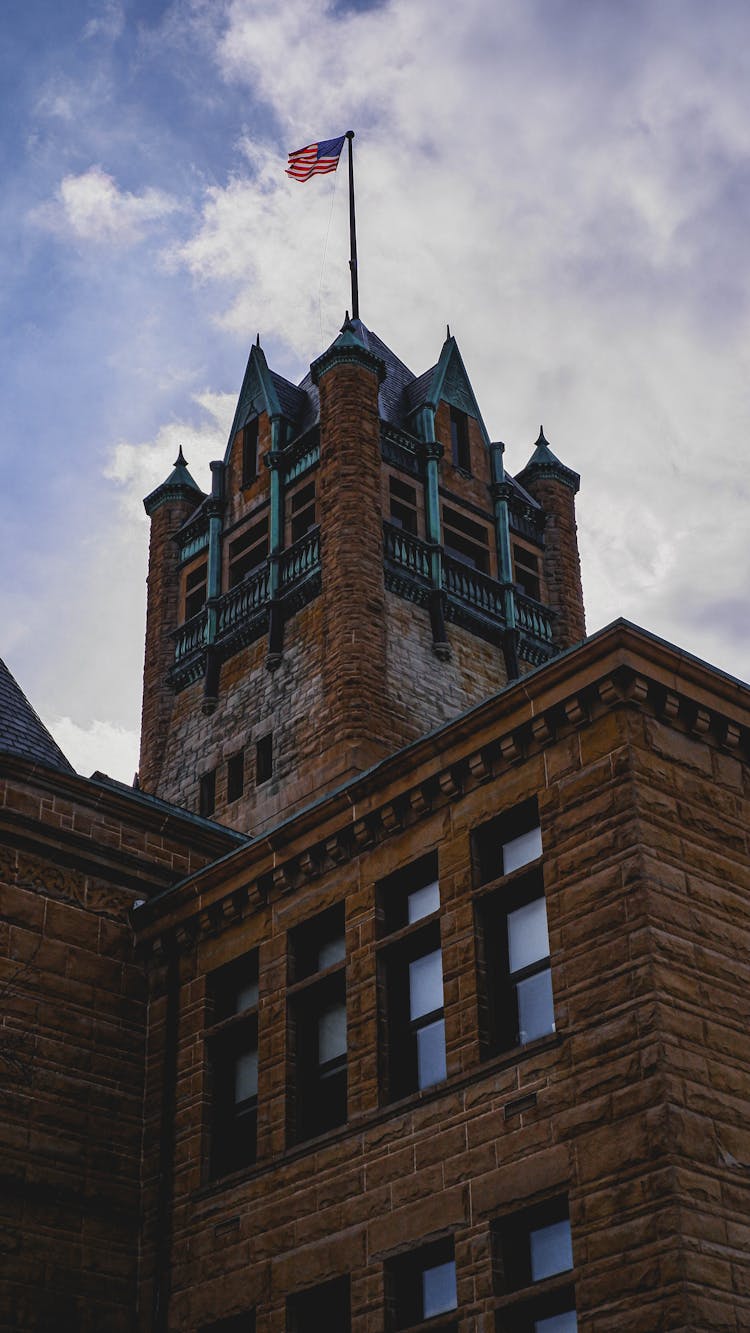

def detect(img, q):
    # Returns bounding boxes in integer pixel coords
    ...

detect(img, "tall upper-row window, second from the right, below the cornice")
[378,854,446,1101]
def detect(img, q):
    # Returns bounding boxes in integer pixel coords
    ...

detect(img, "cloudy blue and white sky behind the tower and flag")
[0,0,750,781]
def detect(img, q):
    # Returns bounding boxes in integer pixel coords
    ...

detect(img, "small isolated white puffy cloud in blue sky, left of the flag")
[32,167,181,245]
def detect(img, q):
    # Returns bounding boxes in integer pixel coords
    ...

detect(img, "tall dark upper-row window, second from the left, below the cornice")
[289,902,346,1141]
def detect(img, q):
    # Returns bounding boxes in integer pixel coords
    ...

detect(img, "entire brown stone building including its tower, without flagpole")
[0,321,750,1333]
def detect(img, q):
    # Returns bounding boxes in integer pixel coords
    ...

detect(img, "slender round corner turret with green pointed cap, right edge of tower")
[516,427,586,649]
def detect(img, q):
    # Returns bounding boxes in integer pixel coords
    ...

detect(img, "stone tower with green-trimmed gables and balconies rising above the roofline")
[140,319,585,833]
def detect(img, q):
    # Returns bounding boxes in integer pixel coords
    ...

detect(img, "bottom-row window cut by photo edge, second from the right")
[385,1237,458,1329]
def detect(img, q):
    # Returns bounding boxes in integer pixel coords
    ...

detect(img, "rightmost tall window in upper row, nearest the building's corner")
[474,801,554,1054]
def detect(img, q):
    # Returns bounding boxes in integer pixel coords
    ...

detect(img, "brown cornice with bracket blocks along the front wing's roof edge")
[133,621,750,949]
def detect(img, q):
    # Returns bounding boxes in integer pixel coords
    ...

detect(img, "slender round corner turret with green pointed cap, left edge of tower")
[139,448,205,792]
